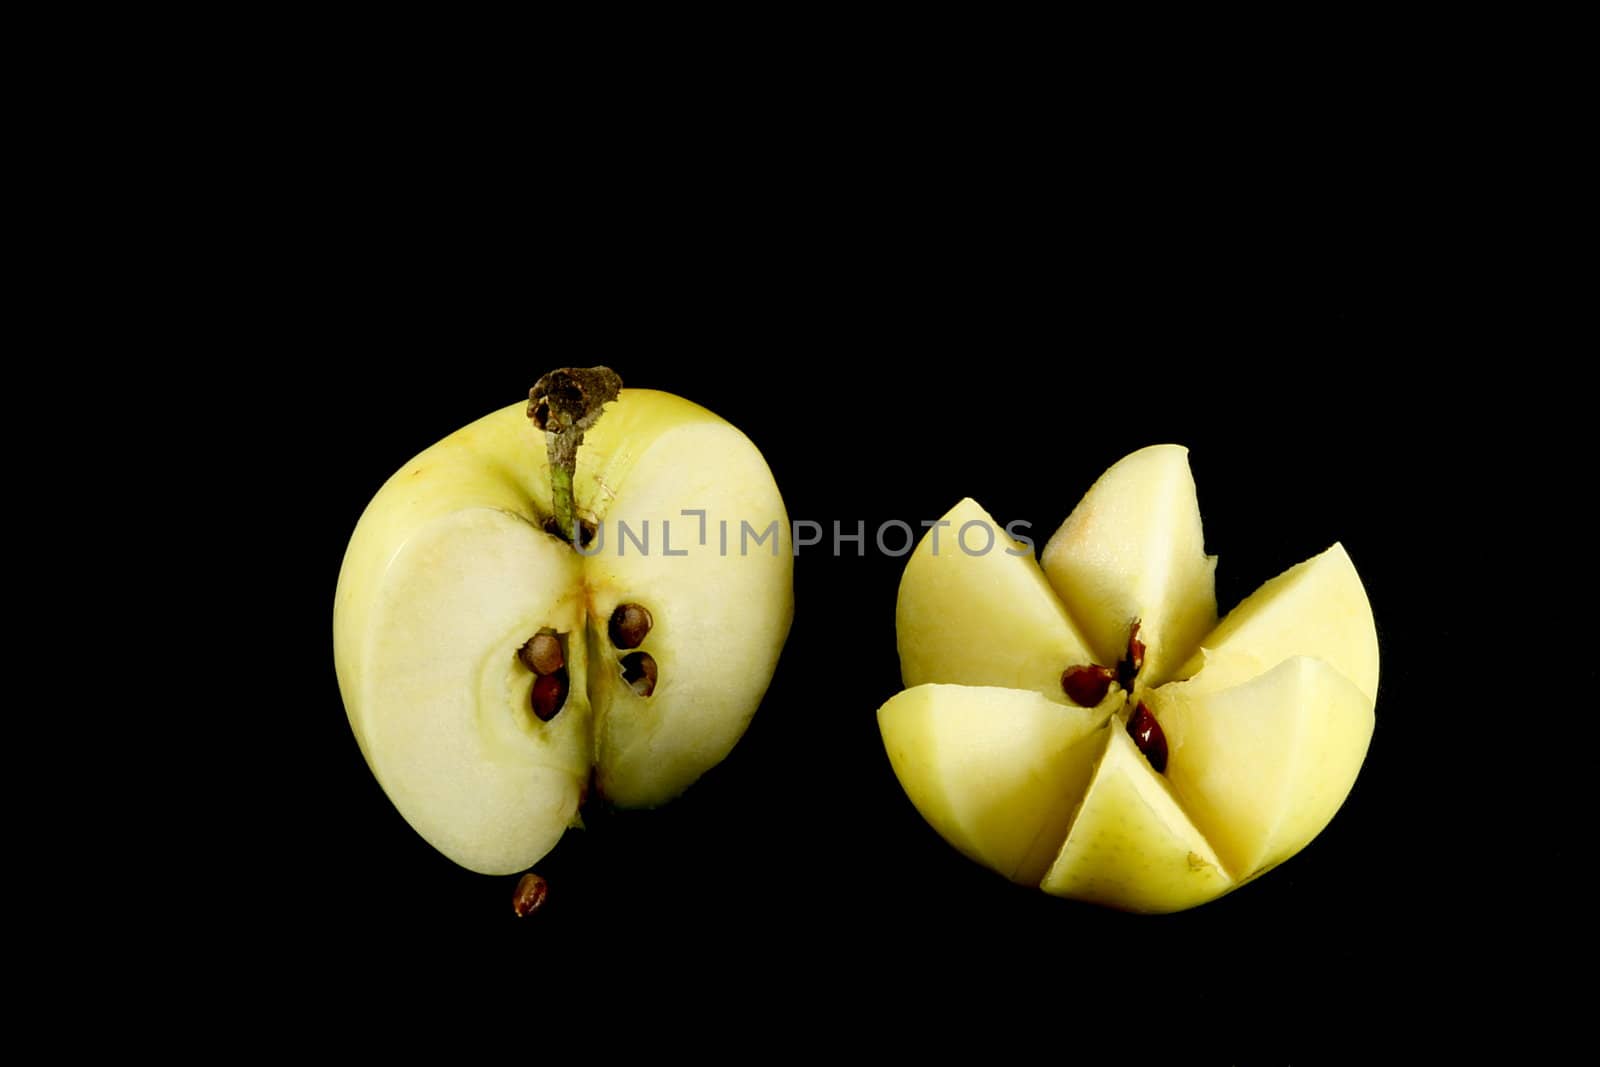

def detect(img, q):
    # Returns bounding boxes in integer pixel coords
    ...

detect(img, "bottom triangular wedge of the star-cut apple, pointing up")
[1040,723,1234,912]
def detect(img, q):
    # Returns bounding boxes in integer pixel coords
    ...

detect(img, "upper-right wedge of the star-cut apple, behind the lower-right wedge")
[1178,544,1378,707]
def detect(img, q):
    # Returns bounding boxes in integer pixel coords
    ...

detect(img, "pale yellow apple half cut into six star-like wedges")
[878,445,1378,912]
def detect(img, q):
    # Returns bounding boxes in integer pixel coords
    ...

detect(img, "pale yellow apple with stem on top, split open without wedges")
[333,389,794,873]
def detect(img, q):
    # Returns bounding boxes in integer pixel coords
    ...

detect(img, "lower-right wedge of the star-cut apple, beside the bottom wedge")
[1149,656,1373,877]
